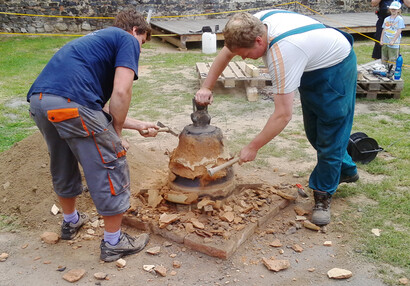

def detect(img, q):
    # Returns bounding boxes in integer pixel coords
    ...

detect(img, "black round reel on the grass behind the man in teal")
[347,132,383,164]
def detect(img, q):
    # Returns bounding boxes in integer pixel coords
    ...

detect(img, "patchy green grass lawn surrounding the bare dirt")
[0,31,410,285]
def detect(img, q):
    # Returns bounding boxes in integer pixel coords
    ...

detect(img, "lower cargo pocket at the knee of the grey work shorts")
[106,157,130,196]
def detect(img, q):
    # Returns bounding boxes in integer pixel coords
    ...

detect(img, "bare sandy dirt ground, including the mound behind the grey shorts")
[0,40,398,286]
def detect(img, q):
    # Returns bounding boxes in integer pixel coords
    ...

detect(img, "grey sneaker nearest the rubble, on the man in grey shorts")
[100,232,149,262]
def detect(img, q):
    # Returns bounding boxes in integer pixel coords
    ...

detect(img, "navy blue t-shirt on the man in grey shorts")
[27,27,140,110]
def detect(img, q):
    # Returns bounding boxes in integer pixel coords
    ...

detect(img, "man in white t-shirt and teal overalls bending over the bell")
[195,10,359,225]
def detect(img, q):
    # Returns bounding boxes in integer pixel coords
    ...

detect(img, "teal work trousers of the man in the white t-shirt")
[299,49,357,195]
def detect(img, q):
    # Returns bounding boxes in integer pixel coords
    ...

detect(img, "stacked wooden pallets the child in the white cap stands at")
[356,60,404,99]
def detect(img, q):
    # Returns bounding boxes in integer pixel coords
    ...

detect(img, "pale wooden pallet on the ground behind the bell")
[196,61,271,101]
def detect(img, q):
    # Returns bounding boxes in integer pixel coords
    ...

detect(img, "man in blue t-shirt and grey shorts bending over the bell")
[27,10,158,261]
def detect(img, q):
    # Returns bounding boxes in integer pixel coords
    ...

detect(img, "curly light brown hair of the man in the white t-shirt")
[223,12,264,51]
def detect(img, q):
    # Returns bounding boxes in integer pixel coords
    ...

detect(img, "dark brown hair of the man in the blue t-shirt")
[114,9,151,41]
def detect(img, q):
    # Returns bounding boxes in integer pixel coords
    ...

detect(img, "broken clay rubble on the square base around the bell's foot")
[123,183,308,259]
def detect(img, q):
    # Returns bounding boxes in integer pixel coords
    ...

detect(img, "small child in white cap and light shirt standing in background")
[380,1,405,70]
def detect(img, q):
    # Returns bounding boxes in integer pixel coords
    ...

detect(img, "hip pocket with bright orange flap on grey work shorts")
[47,108,90,139]
